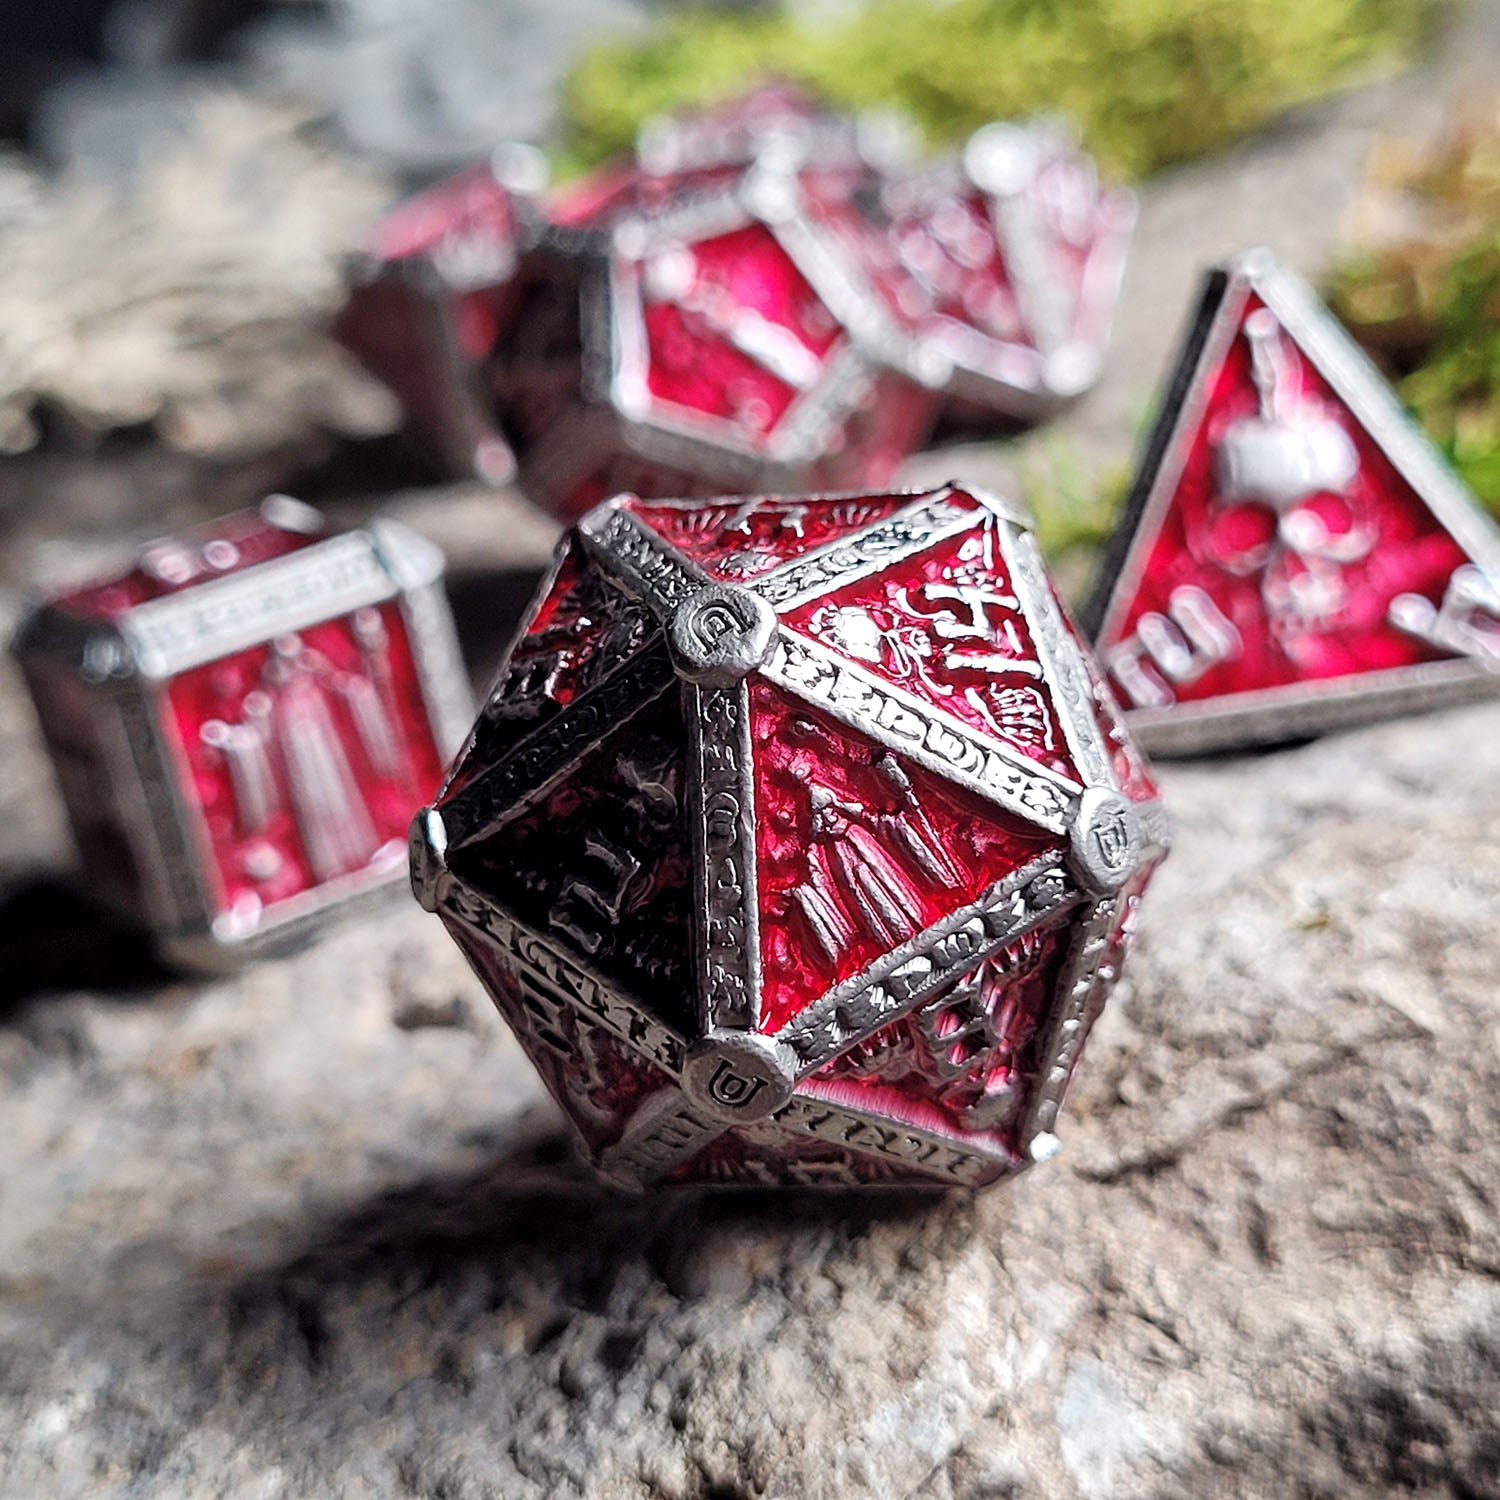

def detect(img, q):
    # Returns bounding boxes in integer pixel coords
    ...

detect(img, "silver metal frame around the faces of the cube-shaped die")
[12,519,473,971]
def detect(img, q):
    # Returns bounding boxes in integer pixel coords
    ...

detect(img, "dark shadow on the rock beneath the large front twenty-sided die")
[227,1118,948,1356]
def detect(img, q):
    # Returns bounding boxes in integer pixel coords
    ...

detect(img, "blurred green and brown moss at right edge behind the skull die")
[1329,105,1500,513]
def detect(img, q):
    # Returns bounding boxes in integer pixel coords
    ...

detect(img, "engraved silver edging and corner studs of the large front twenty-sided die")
[411,485,1169,1188]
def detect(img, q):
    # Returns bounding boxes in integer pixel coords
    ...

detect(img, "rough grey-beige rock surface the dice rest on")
[0,11,1500,1500]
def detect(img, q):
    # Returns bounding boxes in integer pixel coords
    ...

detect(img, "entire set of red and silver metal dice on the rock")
[17,86,1500,1187]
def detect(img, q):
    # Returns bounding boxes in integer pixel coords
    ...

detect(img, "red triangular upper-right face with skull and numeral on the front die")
[782,515,1077,779]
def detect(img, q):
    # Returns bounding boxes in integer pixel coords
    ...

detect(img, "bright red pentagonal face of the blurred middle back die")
[641,224,843,441]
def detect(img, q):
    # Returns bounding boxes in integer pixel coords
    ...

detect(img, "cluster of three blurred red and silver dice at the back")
[339,86,1134,519]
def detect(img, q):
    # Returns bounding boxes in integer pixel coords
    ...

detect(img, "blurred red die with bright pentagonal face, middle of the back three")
[494,155,933,518]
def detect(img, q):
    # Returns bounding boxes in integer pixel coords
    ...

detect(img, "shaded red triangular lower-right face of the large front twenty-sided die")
[804,927,1071,1149]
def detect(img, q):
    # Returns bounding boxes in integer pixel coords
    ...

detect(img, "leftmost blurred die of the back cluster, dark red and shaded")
[335,146,546,485]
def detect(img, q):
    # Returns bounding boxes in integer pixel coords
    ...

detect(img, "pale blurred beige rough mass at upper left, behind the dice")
[0,87,396,462]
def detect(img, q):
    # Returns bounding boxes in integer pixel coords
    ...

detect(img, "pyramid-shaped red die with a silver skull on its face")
[1089,251,1500,762]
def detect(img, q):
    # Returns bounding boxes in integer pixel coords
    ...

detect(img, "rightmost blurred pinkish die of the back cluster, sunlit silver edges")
[884,120,1136,422]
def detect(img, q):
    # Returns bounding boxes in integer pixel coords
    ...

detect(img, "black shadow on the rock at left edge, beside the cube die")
[0,873,173,1022]
